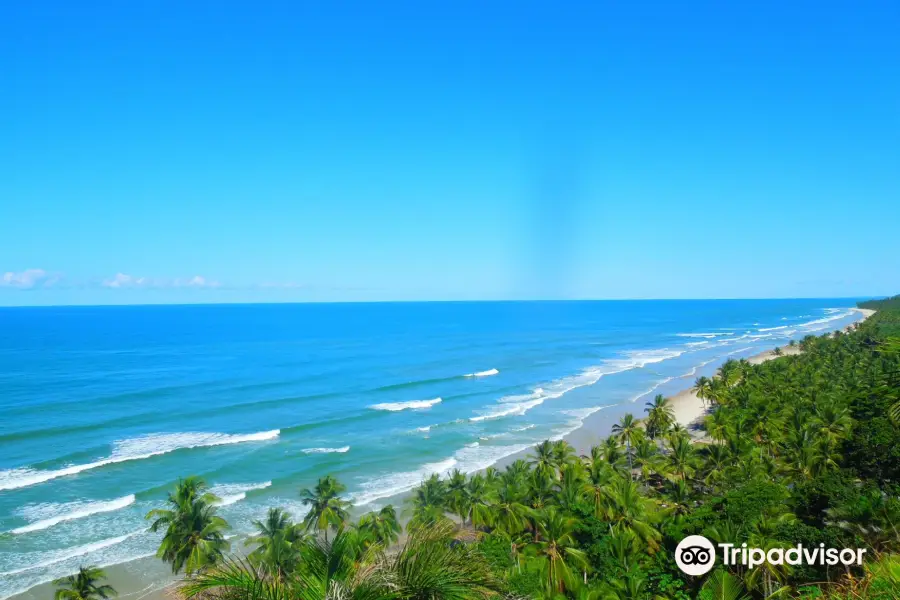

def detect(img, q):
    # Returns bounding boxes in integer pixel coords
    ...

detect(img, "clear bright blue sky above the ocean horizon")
[0,1,900,304]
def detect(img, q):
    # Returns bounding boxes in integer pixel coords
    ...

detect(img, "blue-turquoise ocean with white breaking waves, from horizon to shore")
[0,299,861,598]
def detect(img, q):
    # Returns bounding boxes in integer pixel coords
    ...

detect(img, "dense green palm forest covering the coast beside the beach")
[59,298,900,600]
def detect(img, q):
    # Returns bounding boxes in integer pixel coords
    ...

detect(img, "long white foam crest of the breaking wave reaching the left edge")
[0,429,281,490]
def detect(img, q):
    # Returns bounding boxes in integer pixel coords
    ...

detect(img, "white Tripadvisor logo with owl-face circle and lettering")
[675,535,866,576]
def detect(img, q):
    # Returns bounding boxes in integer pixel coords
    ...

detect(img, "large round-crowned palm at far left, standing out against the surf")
[146,477,229,575]
